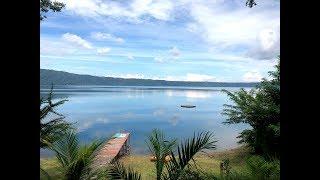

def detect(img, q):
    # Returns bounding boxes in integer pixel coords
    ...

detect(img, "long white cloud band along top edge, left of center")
[62,0,174,21]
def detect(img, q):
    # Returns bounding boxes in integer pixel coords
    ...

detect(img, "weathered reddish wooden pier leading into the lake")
[93,133,130,169]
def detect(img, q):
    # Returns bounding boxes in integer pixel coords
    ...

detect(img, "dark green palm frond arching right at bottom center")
[163,132,217,180]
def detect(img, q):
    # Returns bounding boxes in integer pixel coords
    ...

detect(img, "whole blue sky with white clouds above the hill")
[40,0,280,82]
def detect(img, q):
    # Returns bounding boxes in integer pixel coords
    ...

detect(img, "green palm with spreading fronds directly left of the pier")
[51,131,103,180]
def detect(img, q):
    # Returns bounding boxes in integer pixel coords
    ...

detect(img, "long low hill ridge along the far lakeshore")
[40,69,258,87]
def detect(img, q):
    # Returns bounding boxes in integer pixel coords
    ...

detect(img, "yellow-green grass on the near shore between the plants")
[40,147,251,179]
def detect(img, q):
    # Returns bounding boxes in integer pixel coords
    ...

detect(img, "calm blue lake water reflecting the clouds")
[41,86,247,157]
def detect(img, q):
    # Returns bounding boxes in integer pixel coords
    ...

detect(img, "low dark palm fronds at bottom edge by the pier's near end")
[106,162,141,180]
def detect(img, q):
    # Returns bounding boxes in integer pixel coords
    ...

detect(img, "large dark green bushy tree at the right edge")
[222,56,280,156]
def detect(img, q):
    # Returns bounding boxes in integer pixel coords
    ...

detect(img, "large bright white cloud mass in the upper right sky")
[187,1,280,59]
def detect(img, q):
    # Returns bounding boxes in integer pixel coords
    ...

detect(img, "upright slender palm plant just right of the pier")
[147,129,176,180]
